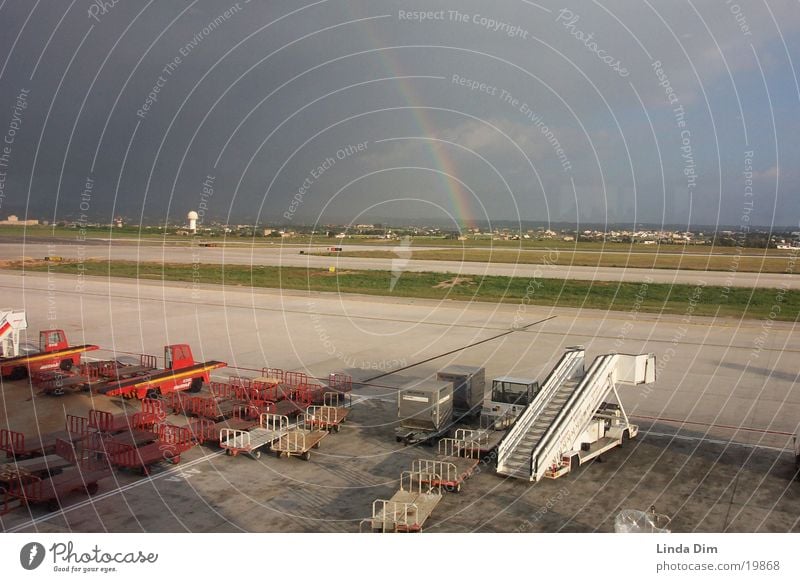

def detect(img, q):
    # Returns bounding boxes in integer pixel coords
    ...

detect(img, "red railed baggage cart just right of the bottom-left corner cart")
[85,424,195,475]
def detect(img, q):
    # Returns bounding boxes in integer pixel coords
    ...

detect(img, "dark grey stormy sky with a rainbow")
[0,0,800,226]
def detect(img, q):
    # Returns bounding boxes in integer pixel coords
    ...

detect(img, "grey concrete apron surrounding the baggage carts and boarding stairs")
[0,271,800,531]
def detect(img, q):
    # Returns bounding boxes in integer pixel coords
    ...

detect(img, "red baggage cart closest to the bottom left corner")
[0,439,111,515]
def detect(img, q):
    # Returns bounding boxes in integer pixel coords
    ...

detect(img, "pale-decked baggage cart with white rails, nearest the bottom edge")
[360,471,442,533]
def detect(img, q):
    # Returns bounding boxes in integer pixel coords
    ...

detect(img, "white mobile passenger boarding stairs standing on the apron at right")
[497,348,655,482]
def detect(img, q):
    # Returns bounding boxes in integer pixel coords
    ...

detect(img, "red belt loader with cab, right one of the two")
[92,344,227,400]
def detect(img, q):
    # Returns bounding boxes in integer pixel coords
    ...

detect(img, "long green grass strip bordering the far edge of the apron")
[8,261,800,321]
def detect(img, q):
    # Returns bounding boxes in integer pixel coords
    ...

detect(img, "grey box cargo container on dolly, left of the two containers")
[395,380,454,445]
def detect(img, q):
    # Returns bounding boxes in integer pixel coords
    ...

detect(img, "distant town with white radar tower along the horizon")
[0,211,800,249]
